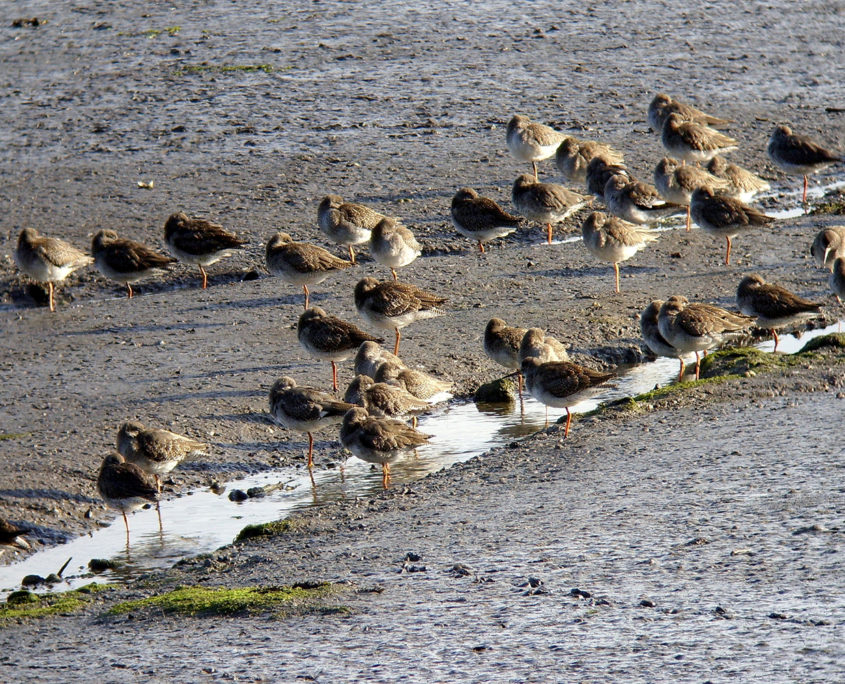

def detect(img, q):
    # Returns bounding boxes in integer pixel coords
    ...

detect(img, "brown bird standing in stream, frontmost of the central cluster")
[340,407,430,489]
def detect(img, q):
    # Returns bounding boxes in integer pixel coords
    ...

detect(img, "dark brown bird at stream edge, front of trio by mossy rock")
[522,358,613,439]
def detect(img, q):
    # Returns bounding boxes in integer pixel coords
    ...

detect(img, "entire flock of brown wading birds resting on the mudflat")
[0,94,845,543]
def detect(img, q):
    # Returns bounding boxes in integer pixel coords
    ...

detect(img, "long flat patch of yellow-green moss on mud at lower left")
[109,582,339,616]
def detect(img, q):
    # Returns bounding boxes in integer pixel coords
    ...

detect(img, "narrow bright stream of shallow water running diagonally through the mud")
[0,323,841,592]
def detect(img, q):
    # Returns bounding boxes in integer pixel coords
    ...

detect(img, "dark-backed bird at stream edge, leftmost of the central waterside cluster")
[270,377,353,469]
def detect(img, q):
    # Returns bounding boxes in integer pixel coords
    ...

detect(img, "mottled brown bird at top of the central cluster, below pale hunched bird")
[355,278,446,355]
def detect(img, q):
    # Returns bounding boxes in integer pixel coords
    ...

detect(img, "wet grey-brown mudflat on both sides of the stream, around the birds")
[0,2,845,682]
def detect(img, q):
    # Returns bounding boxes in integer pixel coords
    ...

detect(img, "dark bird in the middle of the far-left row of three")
[91,230,176,299]
